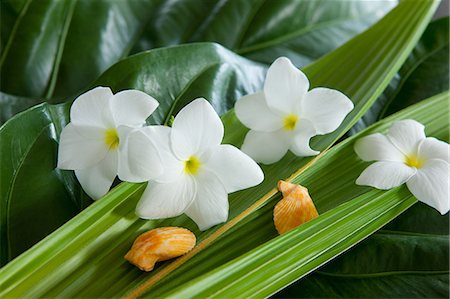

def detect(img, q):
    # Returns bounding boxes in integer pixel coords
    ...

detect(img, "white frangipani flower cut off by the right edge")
[355,119,450,214]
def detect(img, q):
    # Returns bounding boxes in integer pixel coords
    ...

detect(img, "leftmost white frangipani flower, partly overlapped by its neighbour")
[58,87,162,199]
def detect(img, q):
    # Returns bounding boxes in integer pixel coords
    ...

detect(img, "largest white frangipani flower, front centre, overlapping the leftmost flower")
[121,99,264,230]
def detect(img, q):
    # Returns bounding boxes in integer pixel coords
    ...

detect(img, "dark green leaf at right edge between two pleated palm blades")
[349,17,450,134]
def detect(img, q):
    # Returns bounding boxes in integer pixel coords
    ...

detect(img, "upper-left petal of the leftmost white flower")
[70,86,115,128]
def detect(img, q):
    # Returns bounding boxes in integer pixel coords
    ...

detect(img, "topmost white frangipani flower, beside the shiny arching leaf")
[235,57,353,164]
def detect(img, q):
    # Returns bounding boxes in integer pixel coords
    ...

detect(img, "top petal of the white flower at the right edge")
[387,119,426,155]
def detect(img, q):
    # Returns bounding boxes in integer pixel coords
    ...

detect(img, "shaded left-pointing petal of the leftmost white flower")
[58,123,108,170]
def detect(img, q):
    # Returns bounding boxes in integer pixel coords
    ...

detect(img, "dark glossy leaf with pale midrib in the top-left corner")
[0,0,154,100]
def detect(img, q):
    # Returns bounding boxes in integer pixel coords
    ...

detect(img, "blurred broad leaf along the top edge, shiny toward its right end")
[135,0,397,67]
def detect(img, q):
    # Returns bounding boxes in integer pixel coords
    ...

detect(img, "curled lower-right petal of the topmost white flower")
[287,119,320,157]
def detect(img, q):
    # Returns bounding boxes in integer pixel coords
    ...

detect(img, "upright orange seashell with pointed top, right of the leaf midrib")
[273,181,319,235]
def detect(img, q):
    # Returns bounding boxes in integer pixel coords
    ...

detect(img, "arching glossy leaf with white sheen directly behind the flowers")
[95,43,266,124]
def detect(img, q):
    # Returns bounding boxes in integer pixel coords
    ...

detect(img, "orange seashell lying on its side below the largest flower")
[125,227,196,272]
